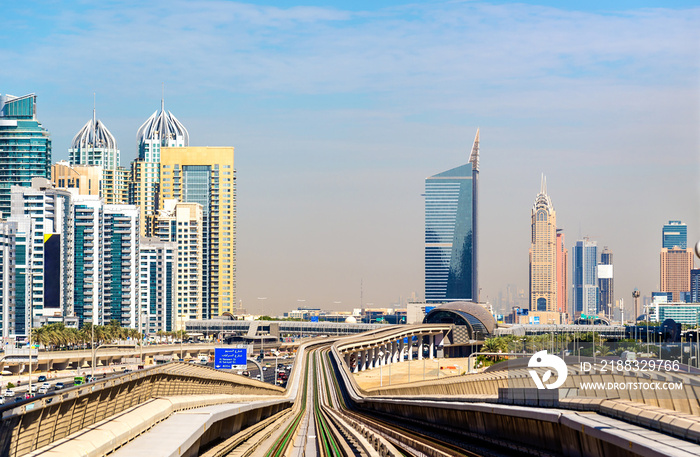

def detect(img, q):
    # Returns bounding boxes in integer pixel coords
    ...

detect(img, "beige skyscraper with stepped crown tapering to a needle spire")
[530,175,564,311]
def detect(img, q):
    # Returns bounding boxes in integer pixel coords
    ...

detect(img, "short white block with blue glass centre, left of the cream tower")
[138,239,174,336]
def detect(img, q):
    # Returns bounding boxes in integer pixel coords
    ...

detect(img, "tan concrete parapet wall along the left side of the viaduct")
[0,362,284,457]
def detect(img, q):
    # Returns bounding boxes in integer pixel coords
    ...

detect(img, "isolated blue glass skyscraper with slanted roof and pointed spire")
[425,129,479,303]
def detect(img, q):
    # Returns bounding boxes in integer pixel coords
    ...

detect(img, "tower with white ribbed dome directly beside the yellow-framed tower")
[129,99,190,236]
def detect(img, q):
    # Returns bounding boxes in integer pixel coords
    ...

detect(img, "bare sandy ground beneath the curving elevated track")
[353,358,468,389]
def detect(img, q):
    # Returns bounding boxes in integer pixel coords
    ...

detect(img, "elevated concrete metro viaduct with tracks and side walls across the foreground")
[5,324,700,457]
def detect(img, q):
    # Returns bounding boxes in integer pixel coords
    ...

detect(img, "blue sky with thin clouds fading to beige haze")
[0,0,700,314]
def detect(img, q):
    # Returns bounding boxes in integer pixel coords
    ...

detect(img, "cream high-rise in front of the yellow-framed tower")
[156,199,202,330]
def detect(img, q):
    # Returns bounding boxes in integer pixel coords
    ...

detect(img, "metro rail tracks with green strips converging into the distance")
[208,341,513,457]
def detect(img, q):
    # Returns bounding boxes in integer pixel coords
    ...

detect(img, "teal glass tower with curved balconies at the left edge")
[0,94,51,218]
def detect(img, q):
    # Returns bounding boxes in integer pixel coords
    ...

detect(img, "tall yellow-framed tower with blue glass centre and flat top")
[159,146,237,319]
